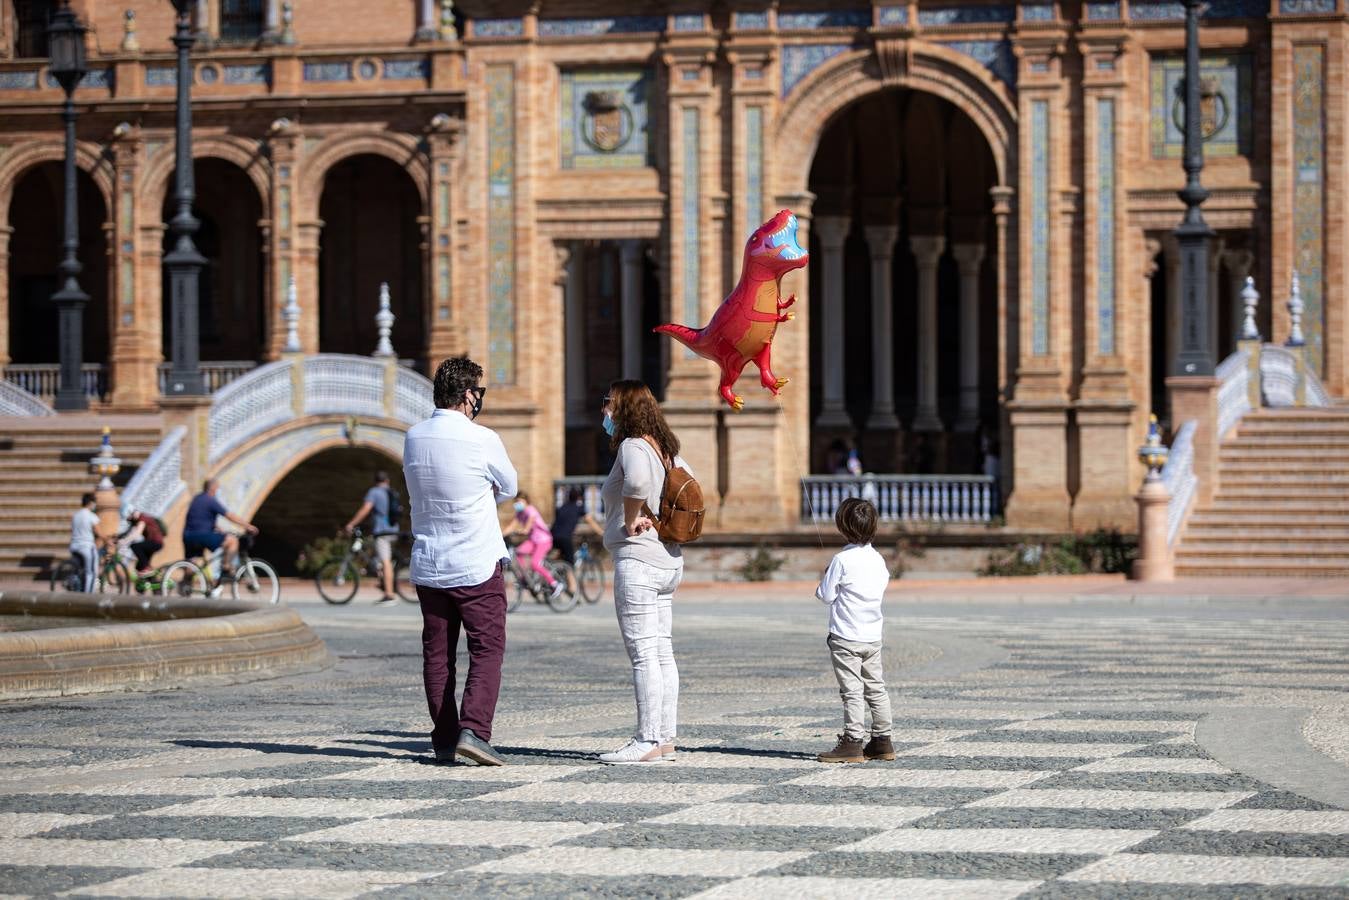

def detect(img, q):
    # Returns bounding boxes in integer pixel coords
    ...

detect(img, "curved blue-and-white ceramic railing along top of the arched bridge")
[206,354,434,464]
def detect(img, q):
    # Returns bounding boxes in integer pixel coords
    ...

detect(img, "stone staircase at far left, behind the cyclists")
[0,414,163,583]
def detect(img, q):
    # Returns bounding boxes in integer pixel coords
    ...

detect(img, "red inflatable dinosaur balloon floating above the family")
[656,209,809,410]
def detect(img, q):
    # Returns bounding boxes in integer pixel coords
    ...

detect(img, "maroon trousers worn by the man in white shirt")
[417,567,506,750]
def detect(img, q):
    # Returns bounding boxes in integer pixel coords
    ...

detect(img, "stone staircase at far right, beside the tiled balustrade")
[1175,407,1349,578]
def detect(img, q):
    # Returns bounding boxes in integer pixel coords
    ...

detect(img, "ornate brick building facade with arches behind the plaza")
[0,0,1349,532]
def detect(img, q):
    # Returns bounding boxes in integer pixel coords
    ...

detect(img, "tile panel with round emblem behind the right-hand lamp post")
[1151,54,1255,159]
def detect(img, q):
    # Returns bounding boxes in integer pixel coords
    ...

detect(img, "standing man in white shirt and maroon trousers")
[403,356,518,765]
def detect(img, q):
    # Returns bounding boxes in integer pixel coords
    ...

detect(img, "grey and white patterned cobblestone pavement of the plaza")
[0,591,1349,899]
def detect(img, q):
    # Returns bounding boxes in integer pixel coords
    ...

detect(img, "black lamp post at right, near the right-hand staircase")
[1171,0,1213,375]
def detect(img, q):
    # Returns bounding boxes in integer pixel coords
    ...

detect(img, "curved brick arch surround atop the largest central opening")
[772,40,1017,196]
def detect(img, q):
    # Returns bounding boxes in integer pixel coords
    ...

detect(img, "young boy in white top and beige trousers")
[815,497,894,762]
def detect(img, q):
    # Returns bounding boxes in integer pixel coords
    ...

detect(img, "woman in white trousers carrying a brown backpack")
[599,381,703,765]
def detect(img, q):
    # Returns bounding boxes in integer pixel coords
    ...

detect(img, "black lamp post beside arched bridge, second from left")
[165,0,206,397]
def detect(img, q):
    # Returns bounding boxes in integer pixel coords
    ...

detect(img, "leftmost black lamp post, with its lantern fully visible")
[47,1,89,410]
